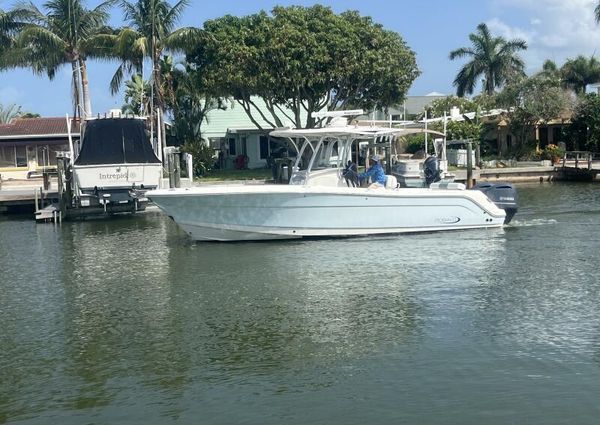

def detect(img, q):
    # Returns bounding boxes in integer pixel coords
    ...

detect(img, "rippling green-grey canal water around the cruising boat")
[0,184,600,425]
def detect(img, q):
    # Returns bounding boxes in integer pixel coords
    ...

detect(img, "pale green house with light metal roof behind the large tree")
[202,97,306,169]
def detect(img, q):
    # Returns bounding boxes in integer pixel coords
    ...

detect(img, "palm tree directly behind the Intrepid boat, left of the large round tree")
[110,0,200,151]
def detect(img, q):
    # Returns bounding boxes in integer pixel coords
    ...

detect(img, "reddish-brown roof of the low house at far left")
[0,117,79,139]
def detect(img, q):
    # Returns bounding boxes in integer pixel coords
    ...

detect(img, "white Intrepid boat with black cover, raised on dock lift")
[58,111,162,217]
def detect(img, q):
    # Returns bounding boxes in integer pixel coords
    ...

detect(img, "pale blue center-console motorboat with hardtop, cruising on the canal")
[147,111,516,241]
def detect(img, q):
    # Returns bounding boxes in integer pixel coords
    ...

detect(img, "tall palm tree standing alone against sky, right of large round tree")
[450,23,527,97]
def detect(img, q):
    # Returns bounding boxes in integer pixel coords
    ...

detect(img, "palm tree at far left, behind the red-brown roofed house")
[11,0,115,116]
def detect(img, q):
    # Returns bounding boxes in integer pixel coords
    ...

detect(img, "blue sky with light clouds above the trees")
[0,0,600,116]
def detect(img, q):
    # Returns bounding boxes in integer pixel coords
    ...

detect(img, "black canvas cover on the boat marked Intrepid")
[75,118,160,165]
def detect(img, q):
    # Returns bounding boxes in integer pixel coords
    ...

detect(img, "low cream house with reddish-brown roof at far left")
[0,117,79,179]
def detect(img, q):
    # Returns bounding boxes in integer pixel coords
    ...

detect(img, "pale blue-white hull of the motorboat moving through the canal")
[147,185,505,241]
